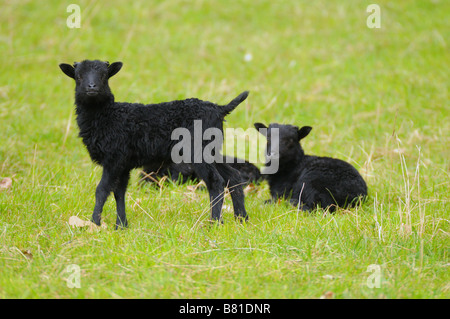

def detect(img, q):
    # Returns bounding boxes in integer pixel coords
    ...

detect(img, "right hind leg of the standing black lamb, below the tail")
[216,163,248,221]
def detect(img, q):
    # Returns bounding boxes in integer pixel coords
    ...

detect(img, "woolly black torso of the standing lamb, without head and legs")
[78,99,223,168]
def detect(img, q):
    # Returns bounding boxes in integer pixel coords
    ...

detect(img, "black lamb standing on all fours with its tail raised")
[59,60,248,228]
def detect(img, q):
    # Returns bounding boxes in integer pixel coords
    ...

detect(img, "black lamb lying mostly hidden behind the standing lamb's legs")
[141,156,263,184]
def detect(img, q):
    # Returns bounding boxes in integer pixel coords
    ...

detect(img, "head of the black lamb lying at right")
[254,123,312,163]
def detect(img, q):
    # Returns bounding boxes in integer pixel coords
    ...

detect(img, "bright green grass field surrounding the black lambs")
[0,1,450,298]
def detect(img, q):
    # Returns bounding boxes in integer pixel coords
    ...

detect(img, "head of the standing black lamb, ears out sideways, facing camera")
[59,60,122,101]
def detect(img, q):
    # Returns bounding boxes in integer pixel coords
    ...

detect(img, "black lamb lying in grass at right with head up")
[254,123,367,212]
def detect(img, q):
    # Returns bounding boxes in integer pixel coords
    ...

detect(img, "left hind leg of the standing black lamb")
[193,163,225,222]
